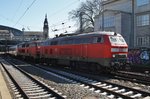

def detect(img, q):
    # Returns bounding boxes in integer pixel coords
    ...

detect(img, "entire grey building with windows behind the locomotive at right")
[94,0,150,48]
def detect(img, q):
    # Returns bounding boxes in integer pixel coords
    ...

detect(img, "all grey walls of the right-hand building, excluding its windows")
[94,0,150,48]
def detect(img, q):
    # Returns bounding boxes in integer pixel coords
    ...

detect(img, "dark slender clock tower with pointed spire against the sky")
[43,14,49,39]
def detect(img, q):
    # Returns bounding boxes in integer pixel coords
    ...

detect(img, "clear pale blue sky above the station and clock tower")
[0,0,85,36]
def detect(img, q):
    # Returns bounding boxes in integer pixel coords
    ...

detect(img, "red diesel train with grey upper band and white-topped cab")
[7,31,128,71]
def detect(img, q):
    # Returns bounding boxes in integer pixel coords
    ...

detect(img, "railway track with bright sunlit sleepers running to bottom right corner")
[33,66,150,99]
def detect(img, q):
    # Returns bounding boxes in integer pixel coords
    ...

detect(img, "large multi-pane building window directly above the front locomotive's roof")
[104,16,115,27]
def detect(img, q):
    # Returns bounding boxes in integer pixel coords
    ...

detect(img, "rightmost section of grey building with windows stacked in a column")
[134,0,150,48]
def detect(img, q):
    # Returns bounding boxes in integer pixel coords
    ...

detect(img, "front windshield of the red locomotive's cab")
[109,36,126,44]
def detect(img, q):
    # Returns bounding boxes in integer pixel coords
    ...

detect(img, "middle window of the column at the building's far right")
[137,14,150,26]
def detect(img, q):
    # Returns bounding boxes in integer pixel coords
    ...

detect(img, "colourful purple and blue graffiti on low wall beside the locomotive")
[128,49,150,64]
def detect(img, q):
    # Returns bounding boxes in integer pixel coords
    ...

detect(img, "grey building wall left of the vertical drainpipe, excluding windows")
[94,0,131,46]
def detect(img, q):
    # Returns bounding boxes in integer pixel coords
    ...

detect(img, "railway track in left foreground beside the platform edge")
[0,58,66,99]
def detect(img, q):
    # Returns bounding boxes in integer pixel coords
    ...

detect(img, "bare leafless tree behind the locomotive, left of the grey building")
[69,0,102,32]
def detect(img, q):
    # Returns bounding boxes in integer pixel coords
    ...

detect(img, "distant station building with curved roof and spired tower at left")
[0,15,49,41]
